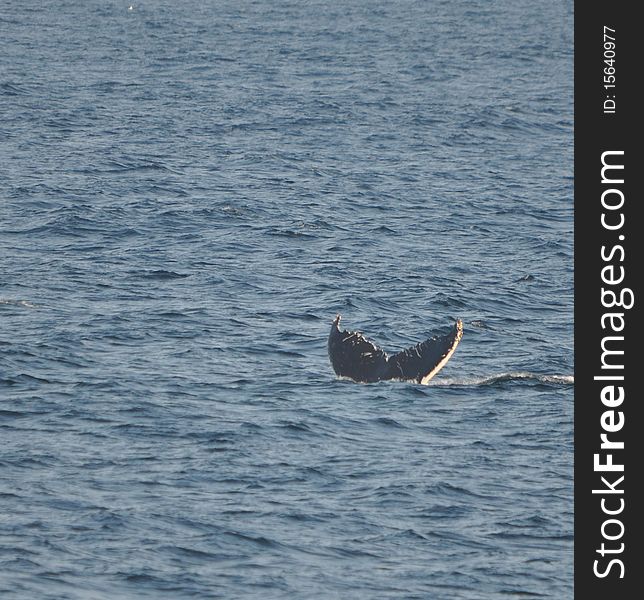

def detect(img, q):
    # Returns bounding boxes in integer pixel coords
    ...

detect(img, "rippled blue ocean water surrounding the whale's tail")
[0,0,574,600]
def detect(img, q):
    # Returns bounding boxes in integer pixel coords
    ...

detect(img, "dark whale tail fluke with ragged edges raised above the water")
[328,315,463,384]
